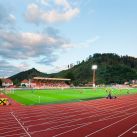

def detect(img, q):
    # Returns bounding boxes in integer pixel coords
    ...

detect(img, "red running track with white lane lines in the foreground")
[0,94,137,137]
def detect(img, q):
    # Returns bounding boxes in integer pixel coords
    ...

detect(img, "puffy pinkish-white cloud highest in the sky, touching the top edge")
[25,0,80,24]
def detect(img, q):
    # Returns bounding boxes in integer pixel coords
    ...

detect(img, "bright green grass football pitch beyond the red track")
[7,88,137,105]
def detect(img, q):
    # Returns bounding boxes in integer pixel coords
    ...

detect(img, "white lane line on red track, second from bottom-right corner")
[85,112,137,137]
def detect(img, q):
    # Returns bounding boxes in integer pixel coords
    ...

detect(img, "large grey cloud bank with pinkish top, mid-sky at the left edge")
[0,28,69,64]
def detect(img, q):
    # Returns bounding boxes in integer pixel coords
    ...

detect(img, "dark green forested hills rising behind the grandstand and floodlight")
[10,53,137,85]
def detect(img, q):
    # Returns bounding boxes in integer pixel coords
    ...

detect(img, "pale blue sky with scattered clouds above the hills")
[0,0,137,77]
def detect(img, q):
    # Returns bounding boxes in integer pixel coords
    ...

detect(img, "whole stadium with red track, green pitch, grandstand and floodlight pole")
[0,67,137,137]
